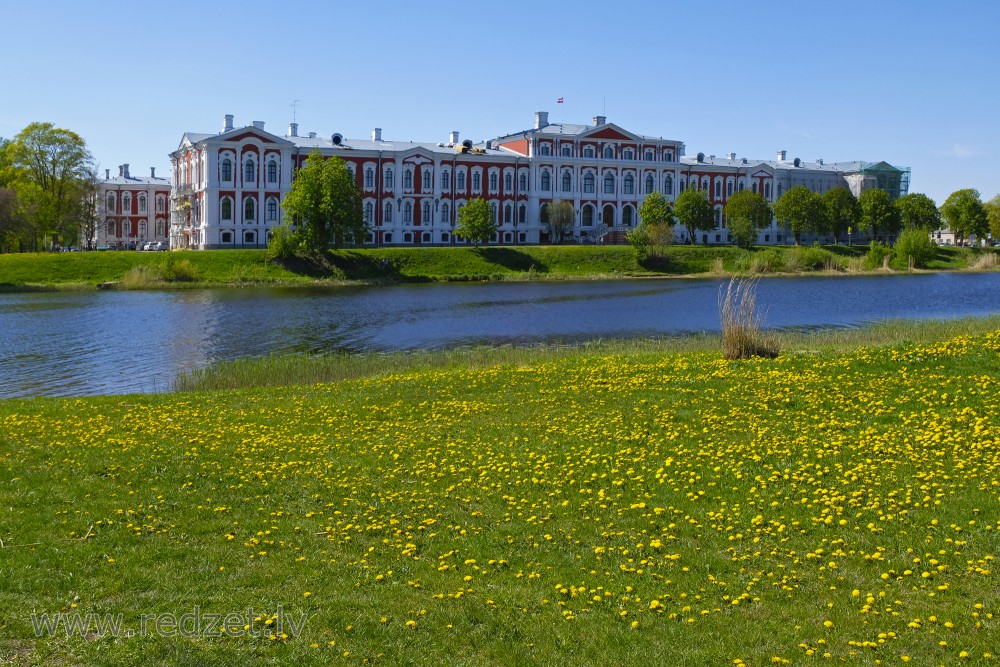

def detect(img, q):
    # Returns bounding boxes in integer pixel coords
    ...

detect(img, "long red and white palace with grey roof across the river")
[169,111,909,249]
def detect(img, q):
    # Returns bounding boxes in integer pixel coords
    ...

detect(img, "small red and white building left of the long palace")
[94,164,171,247]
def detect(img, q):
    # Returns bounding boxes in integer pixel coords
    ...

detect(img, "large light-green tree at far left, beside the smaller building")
[4,123,93,245]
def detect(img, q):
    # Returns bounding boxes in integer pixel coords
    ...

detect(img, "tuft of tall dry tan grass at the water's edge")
[719,278,780,359]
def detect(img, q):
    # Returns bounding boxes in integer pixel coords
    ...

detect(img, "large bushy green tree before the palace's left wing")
[281,150,368,250]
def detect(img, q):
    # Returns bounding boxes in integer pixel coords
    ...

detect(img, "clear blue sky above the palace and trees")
[0,0,1000,204]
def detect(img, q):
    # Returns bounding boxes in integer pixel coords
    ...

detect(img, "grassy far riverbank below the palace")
[0,246,997,291]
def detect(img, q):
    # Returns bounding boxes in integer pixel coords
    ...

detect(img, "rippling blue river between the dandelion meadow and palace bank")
[0,273,1000,397]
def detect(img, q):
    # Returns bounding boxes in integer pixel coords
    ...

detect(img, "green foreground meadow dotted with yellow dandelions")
[0,325,1000,666]
